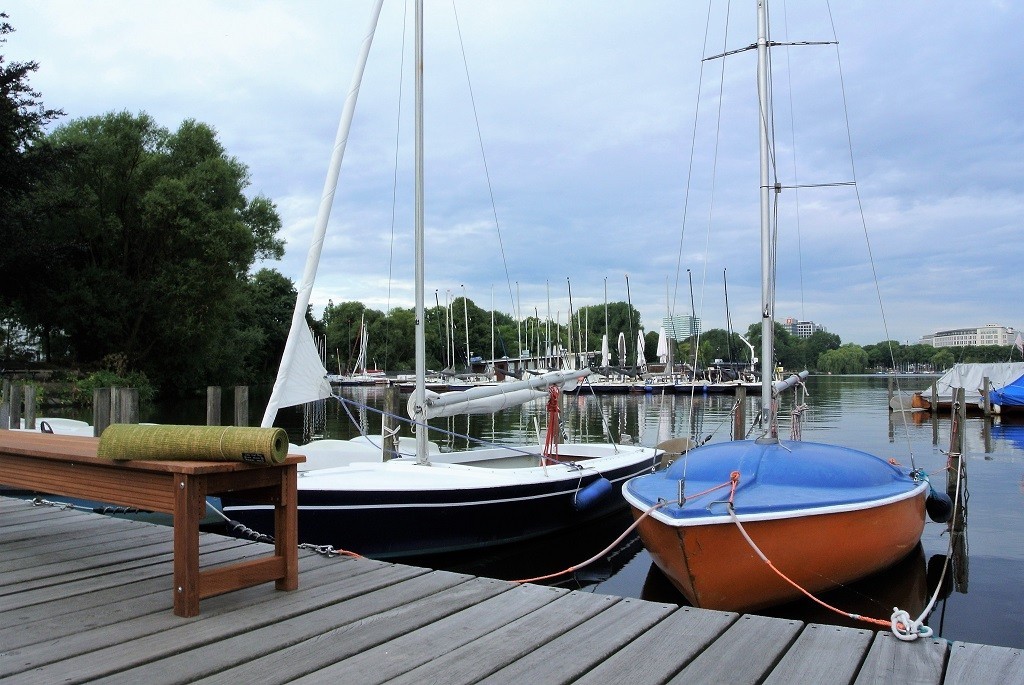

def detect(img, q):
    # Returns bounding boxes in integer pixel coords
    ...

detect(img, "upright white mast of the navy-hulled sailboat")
[413,0,428,464]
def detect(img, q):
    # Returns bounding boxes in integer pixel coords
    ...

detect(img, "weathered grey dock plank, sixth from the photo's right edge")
[475,595,679,684]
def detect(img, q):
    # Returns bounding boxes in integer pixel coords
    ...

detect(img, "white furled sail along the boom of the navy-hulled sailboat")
[408,369,594,419]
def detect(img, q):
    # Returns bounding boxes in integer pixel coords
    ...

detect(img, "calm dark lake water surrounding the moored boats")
[74,376,1024,648]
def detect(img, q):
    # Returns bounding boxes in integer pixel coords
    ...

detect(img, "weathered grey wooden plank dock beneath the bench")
[0,498,1024,685]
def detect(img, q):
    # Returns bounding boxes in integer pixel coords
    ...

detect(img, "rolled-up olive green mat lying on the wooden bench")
[96,424,288,464]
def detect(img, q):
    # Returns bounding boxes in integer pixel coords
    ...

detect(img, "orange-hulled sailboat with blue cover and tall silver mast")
[623,0,929,611]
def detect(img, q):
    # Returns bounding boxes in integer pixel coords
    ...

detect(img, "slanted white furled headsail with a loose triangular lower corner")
[260,0,384,428]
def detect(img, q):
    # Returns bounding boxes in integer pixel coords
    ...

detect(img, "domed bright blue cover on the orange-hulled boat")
[624,440,922,522]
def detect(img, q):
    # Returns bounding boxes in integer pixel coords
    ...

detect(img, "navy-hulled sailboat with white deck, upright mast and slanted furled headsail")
[224,0,660,558]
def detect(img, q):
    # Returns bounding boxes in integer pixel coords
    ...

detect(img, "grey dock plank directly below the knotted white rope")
[854,631,949,685]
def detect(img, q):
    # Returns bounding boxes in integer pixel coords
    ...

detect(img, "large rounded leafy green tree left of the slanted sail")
[19,113,284,388]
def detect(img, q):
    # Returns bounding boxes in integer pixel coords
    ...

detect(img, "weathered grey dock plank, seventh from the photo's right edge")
[389,592,621,685]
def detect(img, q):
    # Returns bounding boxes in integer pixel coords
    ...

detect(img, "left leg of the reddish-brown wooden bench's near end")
[174,473,206,617]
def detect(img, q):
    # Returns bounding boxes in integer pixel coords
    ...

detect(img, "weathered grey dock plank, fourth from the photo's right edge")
[669,614,804,685]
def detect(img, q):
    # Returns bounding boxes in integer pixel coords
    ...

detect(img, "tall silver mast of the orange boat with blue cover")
[758,0,778,440]
